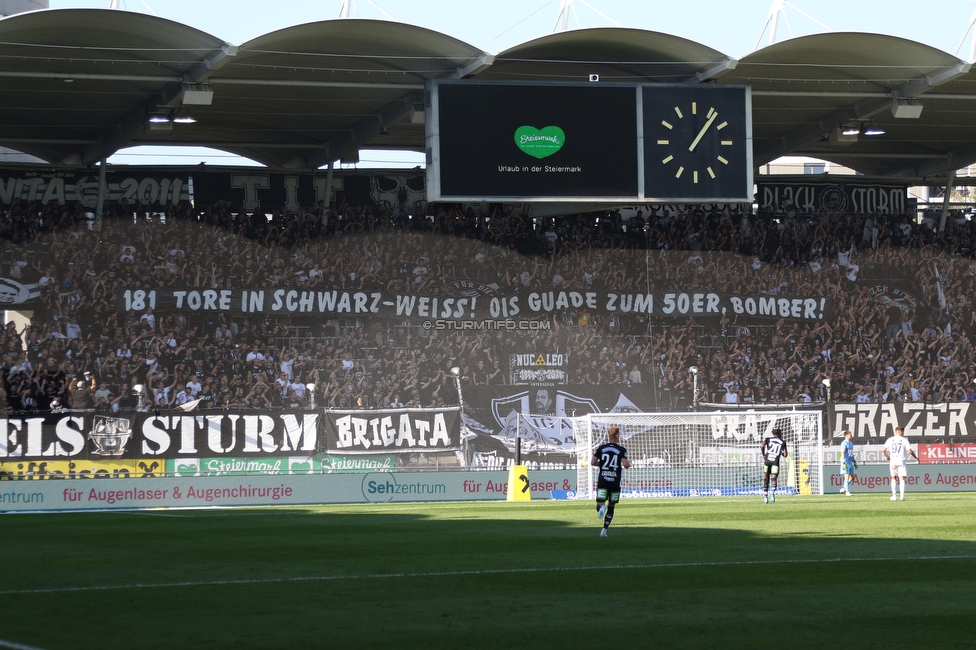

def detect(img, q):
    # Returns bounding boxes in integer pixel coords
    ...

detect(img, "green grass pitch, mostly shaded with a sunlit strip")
[0,494,976,650]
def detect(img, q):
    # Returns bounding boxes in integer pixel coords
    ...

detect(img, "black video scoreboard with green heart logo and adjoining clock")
[426,81,753,204]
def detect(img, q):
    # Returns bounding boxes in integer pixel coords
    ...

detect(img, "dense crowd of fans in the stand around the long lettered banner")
[0,194,976,412]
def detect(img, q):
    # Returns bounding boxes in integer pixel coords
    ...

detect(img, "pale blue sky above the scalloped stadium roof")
[50,0,976,58]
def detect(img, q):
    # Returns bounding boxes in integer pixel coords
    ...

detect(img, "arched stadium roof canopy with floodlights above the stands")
[0,9,976,182]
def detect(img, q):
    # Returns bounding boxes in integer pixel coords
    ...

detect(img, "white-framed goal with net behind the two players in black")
[573,411,823,498]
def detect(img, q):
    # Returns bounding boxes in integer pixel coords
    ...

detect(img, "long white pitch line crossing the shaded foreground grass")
[0,555,976,596]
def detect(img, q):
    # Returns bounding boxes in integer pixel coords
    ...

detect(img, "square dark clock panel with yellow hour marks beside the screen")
[643,86,753,201]
